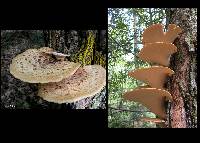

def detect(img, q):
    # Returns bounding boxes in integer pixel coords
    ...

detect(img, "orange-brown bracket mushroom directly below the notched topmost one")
[138,43,177,66]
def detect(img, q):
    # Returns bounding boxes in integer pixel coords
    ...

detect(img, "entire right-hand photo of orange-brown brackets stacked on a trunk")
[108,8,197,128]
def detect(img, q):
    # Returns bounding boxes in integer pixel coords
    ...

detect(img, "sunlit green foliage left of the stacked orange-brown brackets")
[108,8,165,128]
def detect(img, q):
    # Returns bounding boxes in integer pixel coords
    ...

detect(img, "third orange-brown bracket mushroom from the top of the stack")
[128,66,174,89]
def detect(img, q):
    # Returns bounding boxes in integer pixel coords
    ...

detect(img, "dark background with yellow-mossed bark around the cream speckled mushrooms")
[1,30,106,109]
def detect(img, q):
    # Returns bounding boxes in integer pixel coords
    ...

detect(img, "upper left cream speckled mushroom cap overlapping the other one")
[10,47,80,83]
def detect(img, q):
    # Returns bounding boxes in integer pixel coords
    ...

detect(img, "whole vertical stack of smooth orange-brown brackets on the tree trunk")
[123,24,182,123]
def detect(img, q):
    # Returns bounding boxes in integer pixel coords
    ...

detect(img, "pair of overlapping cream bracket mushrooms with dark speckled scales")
[10,47,106,104]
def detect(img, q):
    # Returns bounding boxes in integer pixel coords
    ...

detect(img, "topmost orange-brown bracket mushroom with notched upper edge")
[142,24,182,44]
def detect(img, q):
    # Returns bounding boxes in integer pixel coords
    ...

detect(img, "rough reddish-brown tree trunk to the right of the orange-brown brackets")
[167,8,197,128]
